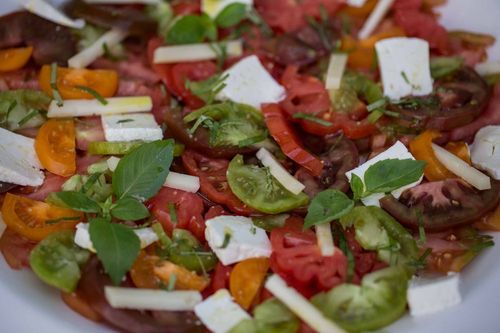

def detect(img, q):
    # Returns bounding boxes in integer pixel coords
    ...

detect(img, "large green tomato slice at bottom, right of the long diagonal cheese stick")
[311,267,408,332]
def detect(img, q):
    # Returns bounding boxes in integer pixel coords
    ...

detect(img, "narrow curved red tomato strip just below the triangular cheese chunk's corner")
[262,104,323,176]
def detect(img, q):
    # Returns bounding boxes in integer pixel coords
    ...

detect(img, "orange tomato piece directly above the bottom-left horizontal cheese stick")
[154,261,210,291]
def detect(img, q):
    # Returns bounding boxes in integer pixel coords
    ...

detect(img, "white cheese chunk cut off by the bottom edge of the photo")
[194,289,251,333]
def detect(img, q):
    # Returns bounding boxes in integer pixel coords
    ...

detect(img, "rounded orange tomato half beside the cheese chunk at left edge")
[35,119,76,177]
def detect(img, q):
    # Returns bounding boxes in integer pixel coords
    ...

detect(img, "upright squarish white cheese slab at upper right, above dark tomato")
[375,37,432,100]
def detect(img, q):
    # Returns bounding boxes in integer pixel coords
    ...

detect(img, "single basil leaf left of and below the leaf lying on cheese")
[304,189,354,228]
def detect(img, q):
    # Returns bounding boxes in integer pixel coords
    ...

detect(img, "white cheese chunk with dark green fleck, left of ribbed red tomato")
[205,216,271,266]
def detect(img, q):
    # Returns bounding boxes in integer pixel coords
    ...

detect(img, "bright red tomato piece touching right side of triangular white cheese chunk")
[281,66,330,115]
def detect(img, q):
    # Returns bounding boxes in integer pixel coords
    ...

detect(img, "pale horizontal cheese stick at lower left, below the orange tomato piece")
[104,286,202,311]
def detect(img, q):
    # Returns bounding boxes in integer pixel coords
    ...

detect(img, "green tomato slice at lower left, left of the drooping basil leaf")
[30,231,90,292]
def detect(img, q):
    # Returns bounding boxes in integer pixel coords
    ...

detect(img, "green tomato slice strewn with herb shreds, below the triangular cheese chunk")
[184,102,267,147]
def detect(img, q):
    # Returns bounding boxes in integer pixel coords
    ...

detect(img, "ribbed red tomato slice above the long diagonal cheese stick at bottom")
[271,217,347,297]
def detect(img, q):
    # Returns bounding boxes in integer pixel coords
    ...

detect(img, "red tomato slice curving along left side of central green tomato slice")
[182,150,252,215]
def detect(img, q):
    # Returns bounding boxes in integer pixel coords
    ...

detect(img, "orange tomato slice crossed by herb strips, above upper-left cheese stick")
[38,65,118,99]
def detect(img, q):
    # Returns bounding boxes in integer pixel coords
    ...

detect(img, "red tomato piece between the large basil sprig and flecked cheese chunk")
[149,187,205,242]
